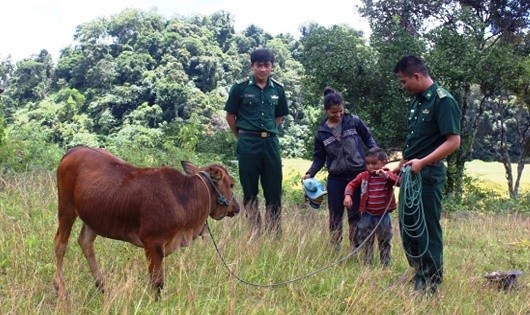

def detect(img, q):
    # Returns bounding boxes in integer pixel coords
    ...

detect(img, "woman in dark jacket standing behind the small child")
[303,87,377,250]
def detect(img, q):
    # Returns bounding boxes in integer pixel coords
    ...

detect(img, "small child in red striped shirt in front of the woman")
[344,147,398,266]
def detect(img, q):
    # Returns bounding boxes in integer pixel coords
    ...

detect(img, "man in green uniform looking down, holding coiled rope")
[394,55,461,295]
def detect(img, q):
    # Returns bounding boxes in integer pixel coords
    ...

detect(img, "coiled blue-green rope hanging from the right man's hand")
[399,165,429,258]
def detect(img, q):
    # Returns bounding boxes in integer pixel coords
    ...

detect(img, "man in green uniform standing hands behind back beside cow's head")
[225,48,289,235]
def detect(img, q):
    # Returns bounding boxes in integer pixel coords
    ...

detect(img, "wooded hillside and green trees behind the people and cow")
[0,0,530,204]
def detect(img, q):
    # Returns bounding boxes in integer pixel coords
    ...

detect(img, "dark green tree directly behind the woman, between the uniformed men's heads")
[299,24,396,147]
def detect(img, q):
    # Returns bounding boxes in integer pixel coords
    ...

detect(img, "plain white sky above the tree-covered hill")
[0,0,370,62]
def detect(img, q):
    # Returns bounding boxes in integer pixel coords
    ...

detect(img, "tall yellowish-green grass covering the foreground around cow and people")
[0,172,530,314]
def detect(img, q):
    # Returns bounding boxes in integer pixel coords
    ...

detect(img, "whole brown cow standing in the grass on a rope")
[55,147,239,298]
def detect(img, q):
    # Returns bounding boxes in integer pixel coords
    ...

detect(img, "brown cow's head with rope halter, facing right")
[181,161,239,220]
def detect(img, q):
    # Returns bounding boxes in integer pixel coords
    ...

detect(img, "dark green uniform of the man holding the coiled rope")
[400,82,460,285]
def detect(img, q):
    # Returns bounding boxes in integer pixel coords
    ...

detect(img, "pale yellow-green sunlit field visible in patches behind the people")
[283,159,530,192]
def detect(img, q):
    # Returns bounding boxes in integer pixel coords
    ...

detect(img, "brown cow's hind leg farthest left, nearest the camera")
[55,200,77,300]
